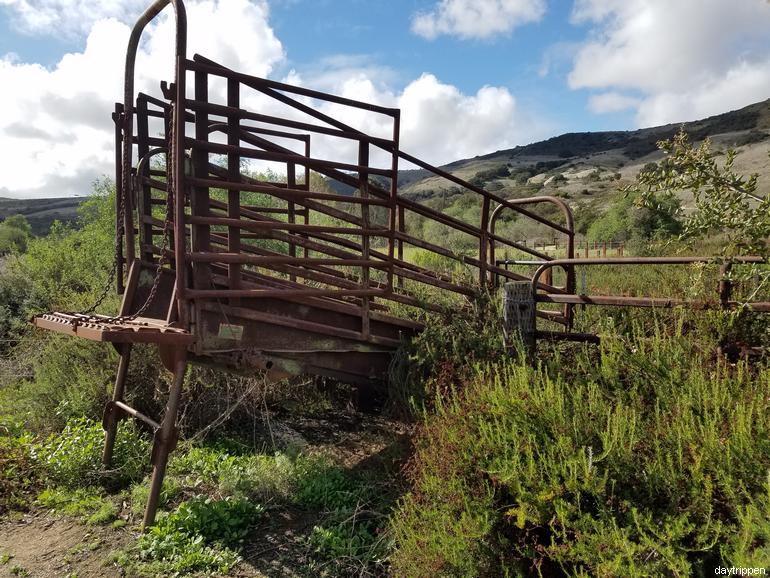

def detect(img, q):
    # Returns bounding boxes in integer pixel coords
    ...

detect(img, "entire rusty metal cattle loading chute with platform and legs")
[27,0,764,525]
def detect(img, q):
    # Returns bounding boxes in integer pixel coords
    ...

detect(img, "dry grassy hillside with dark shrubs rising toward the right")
[390,101,770,212]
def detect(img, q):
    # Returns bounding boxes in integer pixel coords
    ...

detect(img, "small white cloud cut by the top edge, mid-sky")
[412,0,546,40]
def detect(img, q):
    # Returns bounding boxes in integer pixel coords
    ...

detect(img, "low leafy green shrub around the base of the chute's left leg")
[33,418,149,488]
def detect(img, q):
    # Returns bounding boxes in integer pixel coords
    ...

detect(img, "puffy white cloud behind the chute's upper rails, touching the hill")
[275,62,540,168]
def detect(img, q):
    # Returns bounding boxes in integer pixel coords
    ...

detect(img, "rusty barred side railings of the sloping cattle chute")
[115,1,574,339]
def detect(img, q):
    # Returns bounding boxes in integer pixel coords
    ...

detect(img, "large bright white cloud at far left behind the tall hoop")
[0,0,284,196]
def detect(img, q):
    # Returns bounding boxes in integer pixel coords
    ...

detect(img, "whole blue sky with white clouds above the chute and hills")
[0,0,770,196]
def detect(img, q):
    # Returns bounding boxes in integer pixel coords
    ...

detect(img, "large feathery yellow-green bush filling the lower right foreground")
[392,326,770,577]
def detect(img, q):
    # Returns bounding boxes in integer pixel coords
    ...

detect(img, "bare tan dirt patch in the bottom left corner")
[0,513,131,578]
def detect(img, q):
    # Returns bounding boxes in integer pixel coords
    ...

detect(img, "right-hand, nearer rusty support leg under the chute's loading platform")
[142,358,187,529]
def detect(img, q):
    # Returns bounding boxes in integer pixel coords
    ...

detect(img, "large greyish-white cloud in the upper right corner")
[569,0,770,126]
